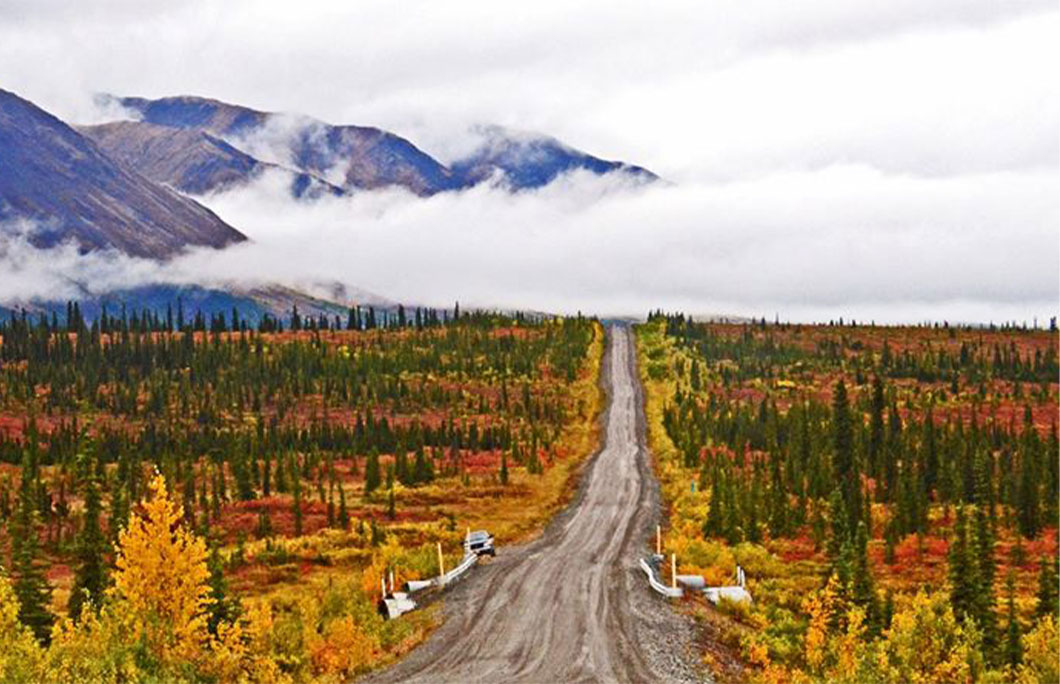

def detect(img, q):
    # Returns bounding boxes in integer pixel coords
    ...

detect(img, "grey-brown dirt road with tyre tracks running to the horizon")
[365,326,702,684]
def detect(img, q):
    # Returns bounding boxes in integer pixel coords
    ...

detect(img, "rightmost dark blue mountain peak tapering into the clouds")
[451,126,658,190]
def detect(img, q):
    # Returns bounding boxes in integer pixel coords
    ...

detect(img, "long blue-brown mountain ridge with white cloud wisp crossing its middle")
[113,97,457,196]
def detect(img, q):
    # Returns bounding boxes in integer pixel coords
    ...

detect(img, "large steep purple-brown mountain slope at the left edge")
[0,90,246,259]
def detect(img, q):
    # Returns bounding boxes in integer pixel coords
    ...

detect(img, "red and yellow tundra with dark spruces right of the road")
[637,313,1060,683]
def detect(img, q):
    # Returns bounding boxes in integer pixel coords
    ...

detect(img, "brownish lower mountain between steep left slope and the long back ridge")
[77,121,342,197]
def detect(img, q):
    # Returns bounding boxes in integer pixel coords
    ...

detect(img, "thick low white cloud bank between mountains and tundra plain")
[0,165,1060,322]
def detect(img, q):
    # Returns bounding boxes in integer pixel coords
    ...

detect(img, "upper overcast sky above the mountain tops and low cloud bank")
[0,0,1060,180]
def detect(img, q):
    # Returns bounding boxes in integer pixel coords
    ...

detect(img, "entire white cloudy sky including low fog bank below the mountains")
[0,0,1060,321]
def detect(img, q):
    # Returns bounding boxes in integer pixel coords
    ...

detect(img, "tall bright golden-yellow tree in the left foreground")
[111,475,210,663]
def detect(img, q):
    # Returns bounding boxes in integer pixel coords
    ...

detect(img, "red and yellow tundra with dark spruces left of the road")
[0,304,603,682]
